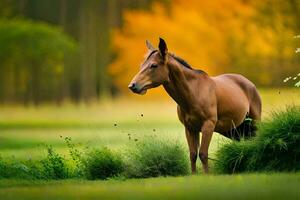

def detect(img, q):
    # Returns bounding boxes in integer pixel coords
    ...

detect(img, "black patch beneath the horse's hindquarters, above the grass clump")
[230,117,257,141]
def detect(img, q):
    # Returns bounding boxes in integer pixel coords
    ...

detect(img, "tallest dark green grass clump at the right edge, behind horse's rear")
[250,106,300,171]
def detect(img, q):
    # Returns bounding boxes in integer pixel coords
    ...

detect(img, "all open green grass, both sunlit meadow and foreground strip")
[0,88,300,199]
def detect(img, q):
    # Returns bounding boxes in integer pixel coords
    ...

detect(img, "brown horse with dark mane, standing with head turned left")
[128,38,261,173]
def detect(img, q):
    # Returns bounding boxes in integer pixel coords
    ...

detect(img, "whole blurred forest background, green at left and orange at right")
[0,0,300,105]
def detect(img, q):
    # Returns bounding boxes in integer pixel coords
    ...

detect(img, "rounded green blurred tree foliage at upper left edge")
[0,19,76,61]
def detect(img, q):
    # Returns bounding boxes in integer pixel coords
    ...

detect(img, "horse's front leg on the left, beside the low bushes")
[185,127,199,174]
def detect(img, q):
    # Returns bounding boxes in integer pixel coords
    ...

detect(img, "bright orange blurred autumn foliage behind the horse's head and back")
[109,0,296,97]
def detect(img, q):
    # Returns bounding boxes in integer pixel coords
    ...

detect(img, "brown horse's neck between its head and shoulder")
[164,59,206,111]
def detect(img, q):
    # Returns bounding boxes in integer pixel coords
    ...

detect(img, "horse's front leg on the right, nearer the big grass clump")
[199,120,216,173]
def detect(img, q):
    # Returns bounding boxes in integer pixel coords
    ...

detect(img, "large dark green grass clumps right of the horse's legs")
[216,106,300,173]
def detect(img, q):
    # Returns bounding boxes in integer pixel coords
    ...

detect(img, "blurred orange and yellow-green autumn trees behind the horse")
[109,0,300,94]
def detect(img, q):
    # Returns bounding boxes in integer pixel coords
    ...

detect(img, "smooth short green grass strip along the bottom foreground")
[0,174,300,200]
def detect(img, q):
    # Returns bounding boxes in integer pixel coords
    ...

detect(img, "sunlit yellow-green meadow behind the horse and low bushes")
[0,88,300,159]
